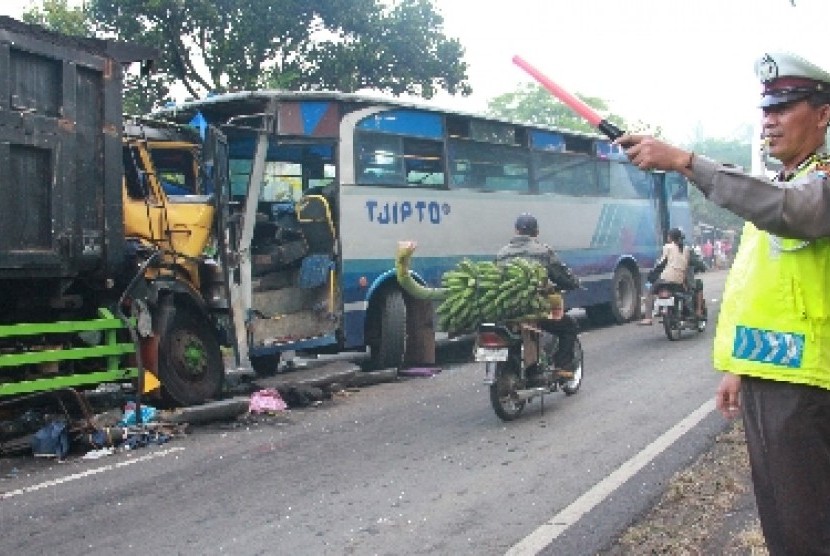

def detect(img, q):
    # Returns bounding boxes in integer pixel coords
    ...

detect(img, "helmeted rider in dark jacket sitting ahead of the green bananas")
[496,213,580,382]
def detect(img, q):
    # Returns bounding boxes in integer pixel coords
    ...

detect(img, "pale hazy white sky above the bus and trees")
[0,0,830,141]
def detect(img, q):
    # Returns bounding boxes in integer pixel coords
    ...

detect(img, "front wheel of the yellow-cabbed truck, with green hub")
[158,303,225,406]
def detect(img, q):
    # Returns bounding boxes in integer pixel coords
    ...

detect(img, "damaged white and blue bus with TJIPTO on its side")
[156,91,691,374]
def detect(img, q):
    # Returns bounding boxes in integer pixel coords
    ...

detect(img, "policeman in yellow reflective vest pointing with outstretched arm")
[617,53,830,556]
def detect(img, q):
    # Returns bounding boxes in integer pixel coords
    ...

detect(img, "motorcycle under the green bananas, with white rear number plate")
[474,323,583,421]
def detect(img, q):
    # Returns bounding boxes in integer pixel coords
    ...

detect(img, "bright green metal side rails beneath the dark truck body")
[0,308,138,398]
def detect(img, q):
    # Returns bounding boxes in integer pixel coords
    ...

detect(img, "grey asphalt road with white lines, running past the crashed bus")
[0,272,726,555]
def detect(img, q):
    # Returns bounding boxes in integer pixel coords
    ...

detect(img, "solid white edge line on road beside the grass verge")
[506,399,715,556]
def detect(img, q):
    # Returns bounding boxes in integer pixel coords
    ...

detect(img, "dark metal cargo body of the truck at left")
[0,17,151,322]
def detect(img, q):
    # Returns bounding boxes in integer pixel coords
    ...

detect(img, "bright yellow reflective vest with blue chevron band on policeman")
[714,157,830,389]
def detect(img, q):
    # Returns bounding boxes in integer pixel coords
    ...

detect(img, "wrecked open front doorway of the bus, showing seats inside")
[221,120,342,372]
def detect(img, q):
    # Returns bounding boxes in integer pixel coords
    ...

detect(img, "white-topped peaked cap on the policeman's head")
[755,52,830,108]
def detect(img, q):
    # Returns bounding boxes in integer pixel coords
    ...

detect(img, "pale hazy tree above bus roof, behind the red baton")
[487,83,648,134]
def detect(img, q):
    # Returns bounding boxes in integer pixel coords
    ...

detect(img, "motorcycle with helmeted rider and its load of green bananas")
[396,214,583,421]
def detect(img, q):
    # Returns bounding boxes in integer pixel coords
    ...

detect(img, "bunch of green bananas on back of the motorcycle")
[438,258,550,333]
